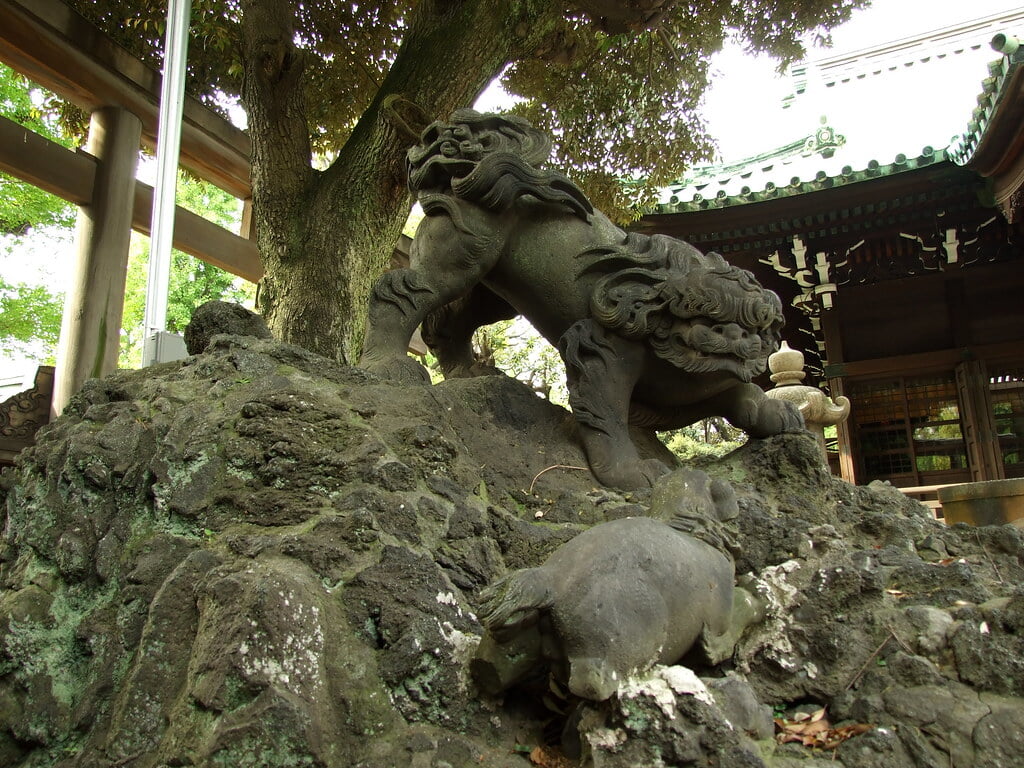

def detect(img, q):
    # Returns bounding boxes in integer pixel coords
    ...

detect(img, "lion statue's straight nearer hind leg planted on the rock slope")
[558,319,669,488]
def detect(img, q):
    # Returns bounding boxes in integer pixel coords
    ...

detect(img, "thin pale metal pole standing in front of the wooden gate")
[142,0,191,366]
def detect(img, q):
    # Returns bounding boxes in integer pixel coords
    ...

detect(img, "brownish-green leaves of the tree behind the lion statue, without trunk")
[61,0,866,218]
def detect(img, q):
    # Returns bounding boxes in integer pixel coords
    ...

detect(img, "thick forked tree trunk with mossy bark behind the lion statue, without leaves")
[243,0,552,364]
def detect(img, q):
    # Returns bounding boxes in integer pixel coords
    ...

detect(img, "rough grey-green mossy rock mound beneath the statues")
[0,336,1024,768]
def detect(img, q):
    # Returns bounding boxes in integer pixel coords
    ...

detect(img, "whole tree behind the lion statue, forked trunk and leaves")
[56,0,866,362]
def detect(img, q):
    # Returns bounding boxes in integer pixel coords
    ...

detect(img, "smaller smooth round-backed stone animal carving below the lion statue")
[471,469,760,701]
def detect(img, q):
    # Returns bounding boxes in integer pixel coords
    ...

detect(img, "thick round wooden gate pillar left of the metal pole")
[52,106,142,417]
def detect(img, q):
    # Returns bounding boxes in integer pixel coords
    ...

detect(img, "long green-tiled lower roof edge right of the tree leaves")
[651,146,947,214]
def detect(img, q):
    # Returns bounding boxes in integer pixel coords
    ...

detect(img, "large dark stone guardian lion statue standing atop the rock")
[360,110,803,488]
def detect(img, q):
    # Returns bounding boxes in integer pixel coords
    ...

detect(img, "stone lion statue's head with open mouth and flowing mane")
[408,110,594,221]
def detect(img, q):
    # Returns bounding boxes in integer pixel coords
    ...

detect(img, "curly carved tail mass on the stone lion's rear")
[578,232,784,381]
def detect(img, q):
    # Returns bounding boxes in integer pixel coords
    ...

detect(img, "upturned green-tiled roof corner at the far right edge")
[950,35,1024,221]
